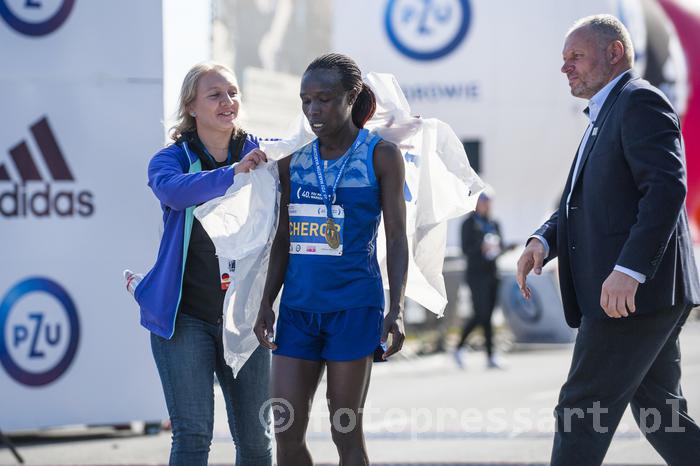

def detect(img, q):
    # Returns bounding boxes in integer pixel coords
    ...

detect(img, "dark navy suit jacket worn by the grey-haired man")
[535,71,700,327]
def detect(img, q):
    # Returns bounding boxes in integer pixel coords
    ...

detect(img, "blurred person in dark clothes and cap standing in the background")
[454,189,506,369]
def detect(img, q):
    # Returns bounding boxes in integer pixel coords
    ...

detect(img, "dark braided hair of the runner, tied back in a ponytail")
[304,53,377,128]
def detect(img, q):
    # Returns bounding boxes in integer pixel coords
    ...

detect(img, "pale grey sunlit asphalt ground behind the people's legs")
[0,321,700,466]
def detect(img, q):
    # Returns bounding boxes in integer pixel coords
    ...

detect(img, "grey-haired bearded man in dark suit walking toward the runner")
[517,15,700,466]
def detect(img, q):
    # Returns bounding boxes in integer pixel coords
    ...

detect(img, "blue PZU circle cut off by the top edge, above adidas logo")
[0,0,75,37]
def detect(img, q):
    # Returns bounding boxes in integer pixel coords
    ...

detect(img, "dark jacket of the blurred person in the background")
[462,212,503,283]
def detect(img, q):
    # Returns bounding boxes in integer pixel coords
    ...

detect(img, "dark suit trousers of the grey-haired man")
[551,307,700,466]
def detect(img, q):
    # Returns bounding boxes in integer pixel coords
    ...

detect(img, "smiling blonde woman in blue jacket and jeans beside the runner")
[134,63,272,466]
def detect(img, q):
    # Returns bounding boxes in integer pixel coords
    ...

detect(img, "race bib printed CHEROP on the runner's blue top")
[289,204,345,256]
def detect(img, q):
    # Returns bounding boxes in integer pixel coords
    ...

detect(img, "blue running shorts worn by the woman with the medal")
[273,304,384,361]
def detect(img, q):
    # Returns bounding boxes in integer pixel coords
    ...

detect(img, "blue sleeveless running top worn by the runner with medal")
[282,129,384,312]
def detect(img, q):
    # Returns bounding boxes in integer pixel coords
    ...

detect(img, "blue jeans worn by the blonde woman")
[151,313,272,466]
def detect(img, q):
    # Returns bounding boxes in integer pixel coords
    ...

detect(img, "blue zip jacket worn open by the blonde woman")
[134,135,258,339]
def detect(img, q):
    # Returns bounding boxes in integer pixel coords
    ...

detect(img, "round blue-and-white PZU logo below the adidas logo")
[0,277,80,387]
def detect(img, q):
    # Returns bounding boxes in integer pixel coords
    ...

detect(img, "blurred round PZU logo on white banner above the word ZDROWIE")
[384,0,471,60]
